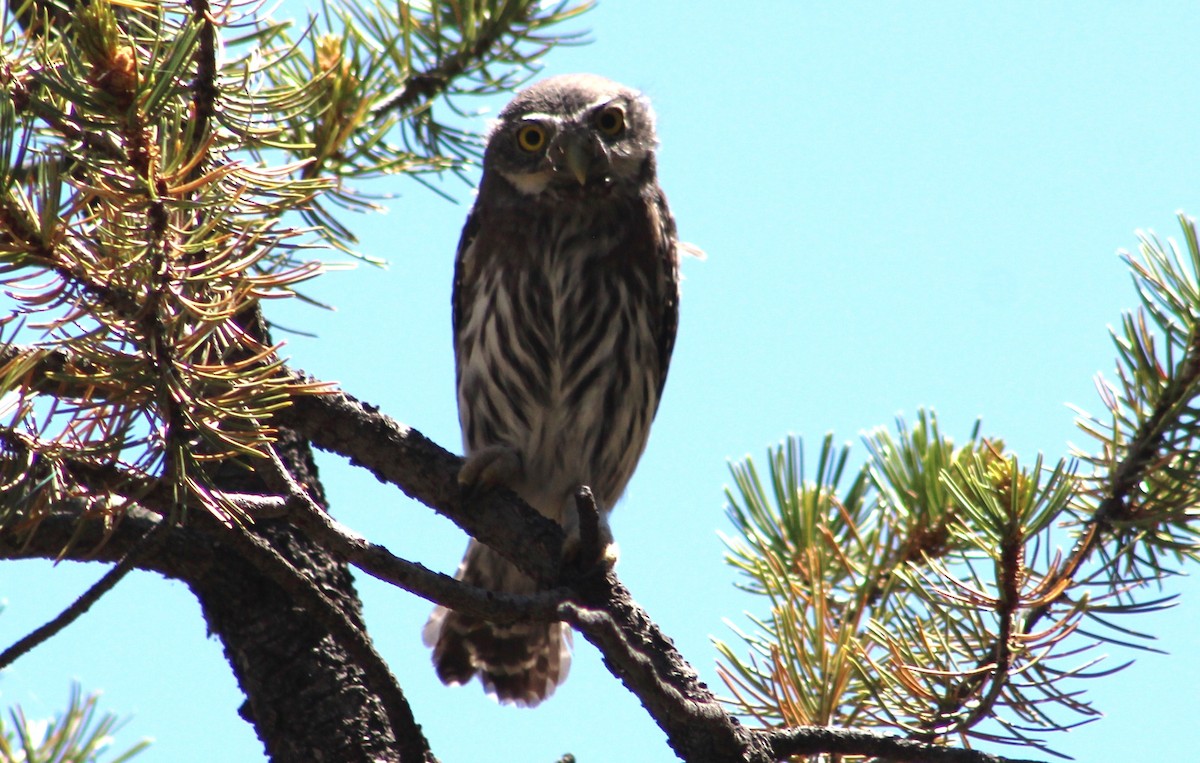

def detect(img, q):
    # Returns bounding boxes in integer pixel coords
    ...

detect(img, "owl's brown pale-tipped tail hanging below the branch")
[421,541,571,708]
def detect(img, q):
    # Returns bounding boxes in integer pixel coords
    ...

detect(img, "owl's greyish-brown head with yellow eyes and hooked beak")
[484,74,658,197]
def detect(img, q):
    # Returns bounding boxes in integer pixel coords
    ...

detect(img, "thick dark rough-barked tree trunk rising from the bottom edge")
[194,308,434,763]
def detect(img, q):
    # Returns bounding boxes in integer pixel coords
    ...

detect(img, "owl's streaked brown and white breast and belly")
[456,202,660,507]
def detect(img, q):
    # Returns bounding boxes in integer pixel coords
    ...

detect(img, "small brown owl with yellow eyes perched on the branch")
[424,74,680,707]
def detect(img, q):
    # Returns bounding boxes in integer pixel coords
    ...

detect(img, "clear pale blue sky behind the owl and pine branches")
[0,0,1200,763]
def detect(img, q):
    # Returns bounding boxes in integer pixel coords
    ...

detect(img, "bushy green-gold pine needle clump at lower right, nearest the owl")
[718,422,1093,746]
